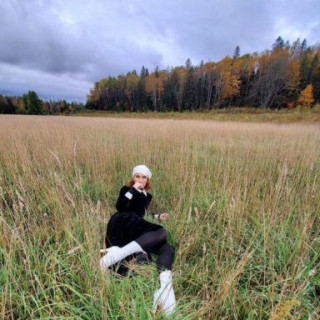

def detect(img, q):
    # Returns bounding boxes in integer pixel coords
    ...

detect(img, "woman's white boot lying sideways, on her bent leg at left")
[100,241,144,270]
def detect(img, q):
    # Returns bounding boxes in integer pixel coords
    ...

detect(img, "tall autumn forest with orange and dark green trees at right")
[86,37,320,111]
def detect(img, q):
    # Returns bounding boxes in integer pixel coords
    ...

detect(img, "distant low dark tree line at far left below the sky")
[0,91,84,114]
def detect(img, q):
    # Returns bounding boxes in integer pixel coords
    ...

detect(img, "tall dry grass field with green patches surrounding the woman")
[0,115,320,320]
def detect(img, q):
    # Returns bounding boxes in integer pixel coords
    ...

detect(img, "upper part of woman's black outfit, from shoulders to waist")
[116,186,152,217]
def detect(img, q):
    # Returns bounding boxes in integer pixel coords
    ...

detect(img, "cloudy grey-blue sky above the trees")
[0,0,320,102]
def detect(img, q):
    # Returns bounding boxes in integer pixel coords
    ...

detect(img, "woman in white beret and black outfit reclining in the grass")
[100,165,176,314]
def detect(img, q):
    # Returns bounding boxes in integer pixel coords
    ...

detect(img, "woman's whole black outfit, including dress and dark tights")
[105,186,174,270]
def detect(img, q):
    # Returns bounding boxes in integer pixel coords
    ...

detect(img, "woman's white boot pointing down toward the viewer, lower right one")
[153,270,176,315]
